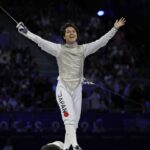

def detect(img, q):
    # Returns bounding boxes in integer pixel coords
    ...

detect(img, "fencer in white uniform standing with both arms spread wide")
[17,17,126,150]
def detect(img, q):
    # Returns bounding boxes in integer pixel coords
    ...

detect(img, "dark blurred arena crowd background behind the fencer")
[0,0,150,150]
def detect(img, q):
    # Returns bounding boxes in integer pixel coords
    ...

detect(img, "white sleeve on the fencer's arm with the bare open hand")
[83,27,117,57]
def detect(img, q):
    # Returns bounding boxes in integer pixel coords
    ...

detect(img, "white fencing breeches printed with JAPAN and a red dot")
[56,80,82,128]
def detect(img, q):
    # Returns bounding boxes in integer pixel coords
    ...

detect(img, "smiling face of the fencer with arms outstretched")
[64,27,77,44]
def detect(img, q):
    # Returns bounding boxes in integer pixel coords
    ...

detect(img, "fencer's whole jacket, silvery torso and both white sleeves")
[24,27,117,90]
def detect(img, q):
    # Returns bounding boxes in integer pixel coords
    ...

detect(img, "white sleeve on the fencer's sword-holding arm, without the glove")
[25,31,61,57]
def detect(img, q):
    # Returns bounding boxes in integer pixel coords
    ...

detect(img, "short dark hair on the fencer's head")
[61,22,79,36]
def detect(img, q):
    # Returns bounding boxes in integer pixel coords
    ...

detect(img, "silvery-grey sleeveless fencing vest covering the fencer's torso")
[57,43,84,90]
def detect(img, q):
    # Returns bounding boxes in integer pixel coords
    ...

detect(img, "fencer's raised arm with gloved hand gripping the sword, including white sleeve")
[16,22,61,57]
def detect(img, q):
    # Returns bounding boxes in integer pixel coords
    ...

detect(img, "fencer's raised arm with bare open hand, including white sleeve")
[83,17,126,57]
